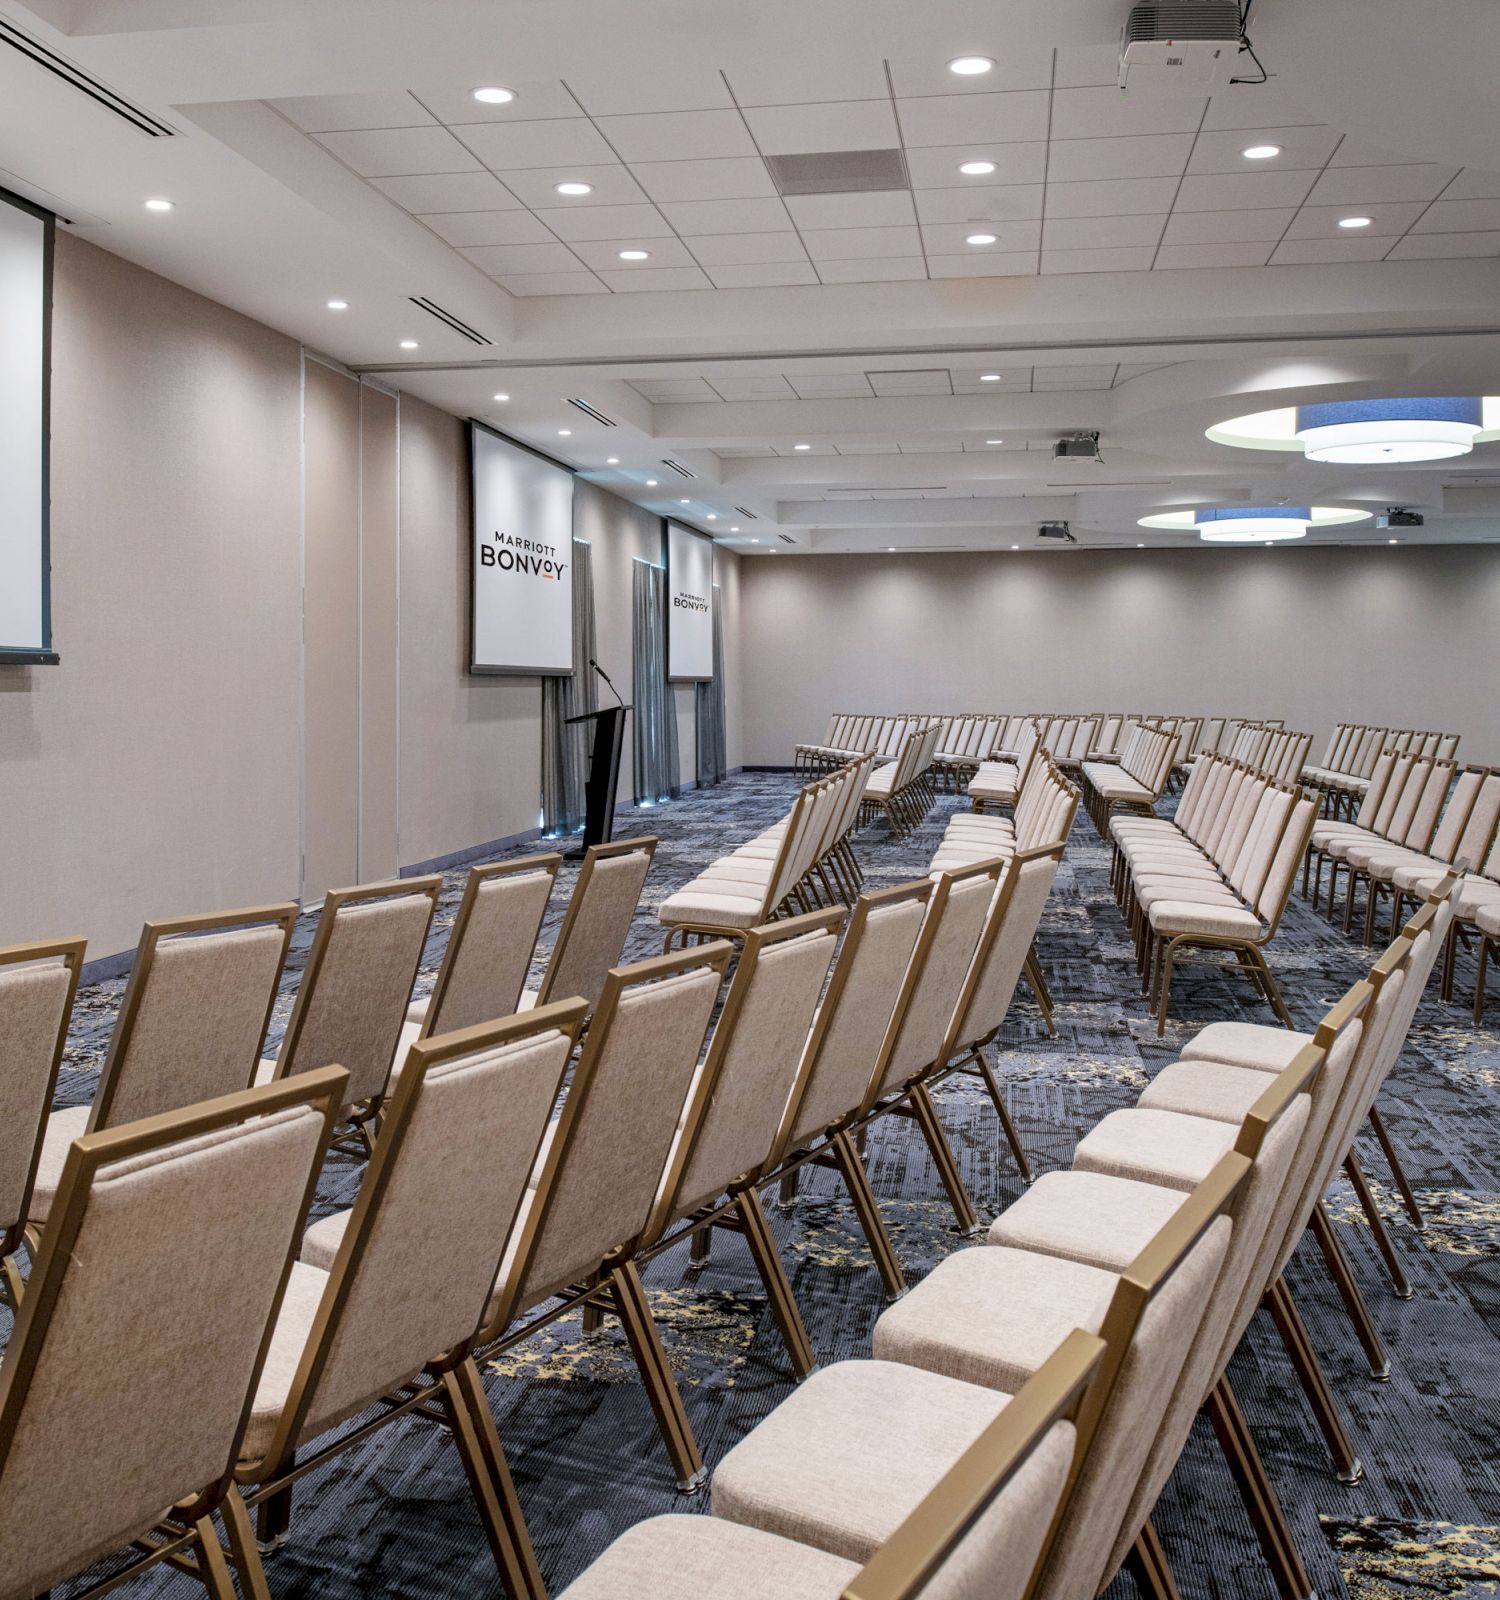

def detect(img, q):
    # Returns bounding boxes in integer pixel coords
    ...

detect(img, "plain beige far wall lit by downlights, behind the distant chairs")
[739,546,1500,765]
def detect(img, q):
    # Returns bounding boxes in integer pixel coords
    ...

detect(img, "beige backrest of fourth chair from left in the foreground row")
[646,907,844,1222]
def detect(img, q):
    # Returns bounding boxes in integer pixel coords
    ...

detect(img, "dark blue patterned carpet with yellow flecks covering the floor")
[14,773,1500,1600]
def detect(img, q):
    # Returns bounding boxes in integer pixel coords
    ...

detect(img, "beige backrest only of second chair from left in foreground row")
[245,1000,585,1475]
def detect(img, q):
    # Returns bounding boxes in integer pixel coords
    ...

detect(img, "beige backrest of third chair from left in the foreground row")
[491,939,731,1333]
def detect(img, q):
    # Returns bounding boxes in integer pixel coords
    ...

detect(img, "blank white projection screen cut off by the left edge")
[0,189,58,666]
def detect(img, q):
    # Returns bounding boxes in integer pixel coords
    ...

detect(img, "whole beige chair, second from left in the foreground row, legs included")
[235,1000,585,1600]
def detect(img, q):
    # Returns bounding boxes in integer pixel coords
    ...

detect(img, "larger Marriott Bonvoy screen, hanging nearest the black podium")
[469,422,572,677]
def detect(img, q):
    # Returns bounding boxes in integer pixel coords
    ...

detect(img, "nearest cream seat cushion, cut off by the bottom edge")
[558,1515,859,1600]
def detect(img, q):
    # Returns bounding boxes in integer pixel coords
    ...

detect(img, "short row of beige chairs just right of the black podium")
[657,755,875,950]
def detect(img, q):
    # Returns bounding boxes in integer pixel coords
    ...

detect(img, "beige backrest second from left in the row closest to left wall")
[88,906,297,1133]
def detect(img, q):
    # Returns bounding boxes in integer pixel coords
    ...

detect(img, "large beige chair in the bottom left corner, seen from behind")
[0,1070,344,1600]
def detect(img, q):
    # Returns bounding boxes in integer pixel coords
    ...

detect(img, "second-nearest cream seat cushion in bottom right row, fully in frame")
[710,1356,1009,1568]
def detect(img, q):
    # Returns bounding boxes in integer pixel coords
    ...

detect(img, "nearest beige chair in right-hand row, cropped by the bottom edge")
[561,1330,1105,1600]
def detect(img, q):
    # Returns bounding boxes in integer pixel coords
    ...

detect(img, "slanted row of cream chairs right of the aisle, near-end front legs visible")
[1108,755,1318,1035]
